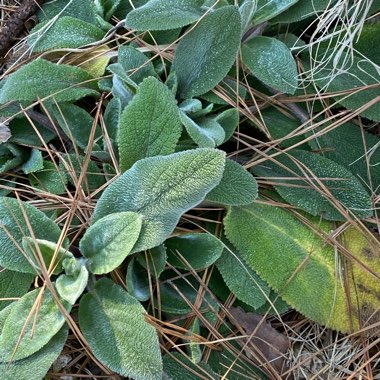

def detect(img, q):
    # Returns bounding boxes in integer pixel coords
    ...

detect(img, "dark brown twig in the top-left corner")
[0,0,43,58]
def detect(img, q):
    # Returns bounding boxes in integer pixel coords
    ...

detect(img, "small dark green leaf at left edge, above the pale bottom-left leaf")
[0,268,34,310]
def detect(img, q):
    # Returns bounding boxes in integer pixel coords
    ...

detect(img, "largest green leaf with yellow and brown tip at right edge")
[224,204,380,332]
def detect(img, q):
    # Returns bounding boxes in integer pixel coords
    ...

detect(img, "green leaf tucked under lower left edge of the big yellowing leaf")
[216,249,270,309]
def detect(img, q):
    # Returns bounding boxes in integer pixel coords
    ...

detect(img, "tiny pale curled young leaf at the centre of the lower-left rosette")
[56,257,88,305]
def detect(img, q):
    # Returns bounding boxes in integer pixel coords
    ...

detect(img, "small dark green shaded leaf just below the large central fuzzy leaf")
[165,233,224,270]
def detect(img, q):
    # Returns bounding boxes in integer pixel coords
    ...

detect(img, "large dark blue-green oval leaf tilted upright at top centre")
[173,6,241,98]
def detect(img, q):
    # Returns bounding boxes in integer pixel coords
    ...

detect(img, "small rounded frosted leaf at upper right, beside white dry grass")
[242,36,298,94]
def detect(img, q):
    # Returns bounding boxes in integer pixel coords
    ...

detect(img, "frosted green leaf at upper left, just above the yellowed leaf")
[28,16,105,52]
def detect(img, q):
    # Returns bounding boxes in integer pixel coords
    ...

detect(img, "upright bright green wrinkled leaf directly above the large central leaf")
[119,77,181,171]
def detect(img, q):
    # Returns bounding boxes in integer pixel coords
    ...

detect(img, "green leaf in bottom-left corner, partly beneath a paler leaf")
[0,327,68,380]
